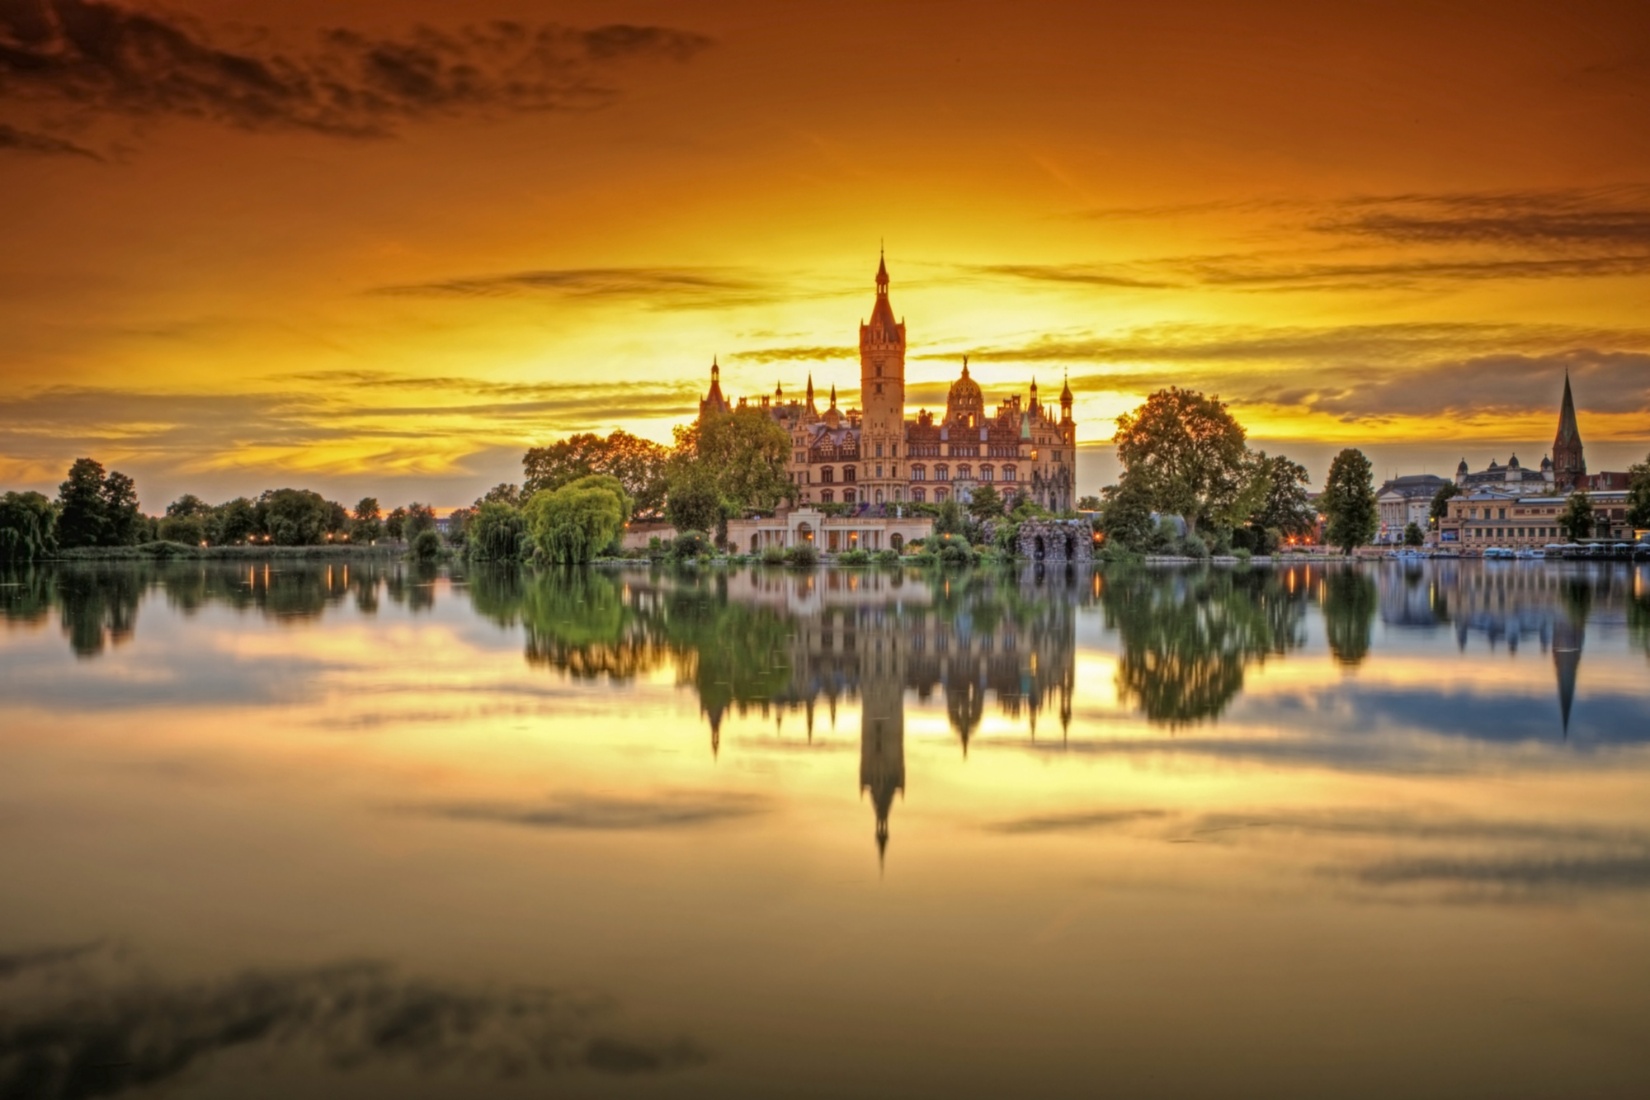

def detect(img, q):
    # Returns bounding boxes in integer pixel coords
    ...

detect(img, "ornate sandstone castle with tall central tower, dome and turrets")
[700,259,1077,513]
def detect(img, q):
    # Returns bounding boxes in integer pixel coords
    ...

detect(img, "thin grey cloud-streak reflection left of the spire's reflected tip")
[413,792,769,831]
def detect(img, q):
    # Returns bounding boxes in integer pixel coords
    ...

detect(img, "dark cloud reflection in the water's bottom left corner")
[0,943,708,1100]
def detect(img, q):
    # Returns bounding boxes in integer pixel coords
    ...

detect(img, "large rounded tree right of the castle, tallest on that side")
[1117,388,1254,533]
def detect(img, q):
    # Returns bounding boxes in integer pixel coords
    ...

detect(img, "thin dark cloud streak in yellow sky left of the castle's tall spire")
[368,267,789,310]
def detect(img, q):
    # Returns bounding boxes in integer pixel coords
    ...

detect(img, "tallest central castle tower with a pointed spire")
[860,259,906,505]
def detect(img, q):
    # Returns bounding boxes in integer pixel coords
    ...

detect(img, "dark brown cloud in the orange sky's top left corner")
[0,0,711,155]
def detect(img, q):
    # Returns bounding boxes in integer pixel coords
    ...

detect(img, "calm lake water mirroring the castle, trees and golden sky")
[0,562,1650,1100]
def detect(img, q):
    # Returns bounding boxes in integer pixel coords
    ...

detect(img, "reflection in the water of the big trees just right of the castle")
[1101,567,1312,729]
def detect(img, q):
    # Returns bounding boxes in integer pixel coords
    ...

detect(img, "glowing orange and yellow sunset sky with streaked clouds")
[0,0,1650,513]
